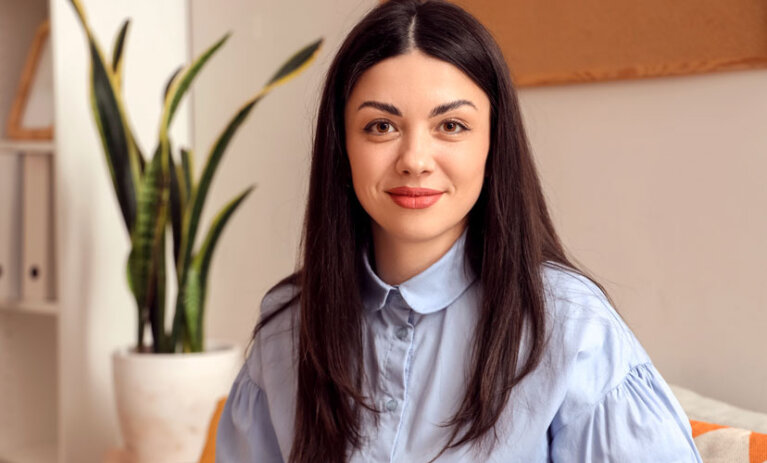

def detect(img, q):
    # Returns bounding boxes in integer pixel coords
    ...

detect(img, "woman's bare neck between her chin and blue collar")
[372,221,466,286]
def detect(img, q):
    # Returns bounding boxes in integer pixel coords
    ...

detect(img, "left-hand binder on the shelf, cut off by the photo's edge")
[0,153,21,302]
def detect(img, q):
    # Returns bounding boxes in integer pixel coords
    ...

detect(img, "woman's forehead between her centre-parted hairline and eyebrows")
[347,50,490,114]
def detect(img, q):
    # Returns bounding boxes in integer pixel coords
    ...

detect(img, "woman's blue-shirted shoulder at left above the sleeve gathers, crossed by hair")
[246,274,300,385]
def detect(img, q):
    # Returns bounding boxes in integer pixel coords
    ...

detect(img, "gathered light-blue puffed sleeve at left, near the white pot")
[216,364,282,463]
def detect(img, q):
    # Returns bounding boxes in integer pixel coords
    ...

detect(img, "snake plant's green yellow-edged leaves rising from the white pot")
[71,0,322,353]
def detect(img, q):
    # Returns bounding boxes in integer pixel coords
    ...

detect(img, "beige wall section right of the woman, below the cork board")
[521,71,767,412]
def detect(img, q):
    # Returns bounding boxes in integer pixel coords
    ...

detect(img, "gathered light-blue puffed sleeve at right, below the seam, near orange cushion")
[551,362,701,463]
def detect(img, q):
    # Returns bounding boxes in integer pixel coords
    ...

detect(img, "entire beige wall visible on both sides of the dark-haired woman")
[191,0,767,412]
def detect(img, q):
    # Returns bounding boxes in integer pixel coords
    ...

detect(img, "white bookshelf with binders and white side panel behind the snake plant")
[0,0,196,463]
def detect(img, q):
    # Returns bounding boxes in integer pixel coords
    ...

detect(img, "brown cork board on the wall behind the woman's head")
[438,0,767,86]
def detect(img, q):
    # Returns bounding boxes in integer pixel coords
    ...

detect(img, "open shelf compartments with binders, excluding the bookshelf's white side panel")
[0,0,59,463]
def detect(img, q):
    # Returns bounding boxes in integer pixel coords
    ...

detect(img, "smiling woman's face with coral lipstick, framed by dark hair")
[344,50,490,246]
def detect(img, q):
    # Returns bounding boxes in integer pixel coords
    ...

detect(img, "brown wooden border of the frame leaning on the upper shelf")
[6,20,53,140]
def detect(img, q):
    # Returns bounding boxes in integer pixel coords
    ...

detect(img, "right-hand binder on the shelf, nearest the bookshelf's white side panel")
[21,153,53,302]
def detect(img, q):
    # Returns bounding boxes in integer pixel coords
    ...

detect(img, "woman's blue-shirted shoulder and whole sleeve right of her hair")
[543,264,700,461]
